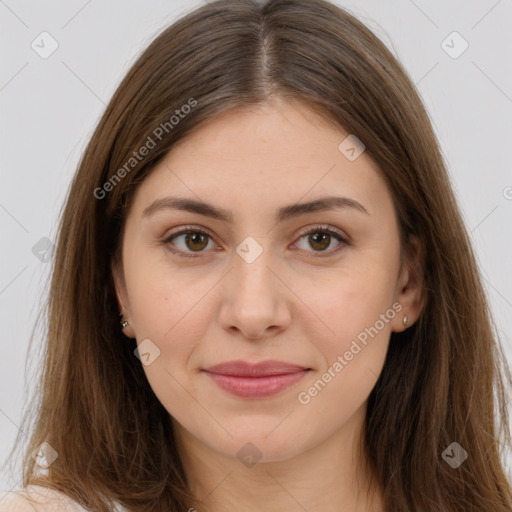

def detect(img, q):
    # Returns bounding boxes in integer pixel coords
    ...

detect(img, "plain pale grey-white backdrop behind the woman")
[0,0,512,489]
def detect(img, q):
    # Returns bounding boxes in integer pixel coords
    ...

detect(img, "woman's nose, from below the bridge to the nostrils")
[219,240,292,341]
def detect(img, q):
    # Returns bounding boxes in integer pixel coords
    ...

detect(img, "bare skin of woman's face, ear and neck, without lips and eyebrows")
[112,97,422,512]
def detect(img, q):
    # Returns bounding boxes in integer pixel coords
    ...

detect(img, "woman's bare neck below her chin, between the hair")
[173,407,384,512]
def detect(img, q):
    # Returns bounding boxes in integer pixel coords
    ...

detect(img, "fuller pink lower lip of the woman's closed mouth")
[205,370,309,398]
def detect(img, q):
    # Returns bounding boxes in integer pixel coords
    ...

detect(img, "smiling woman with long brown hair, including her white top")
[0,0,512,512]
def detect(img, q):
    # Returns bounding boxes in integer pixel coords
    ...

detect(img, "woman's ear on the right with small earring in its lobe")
[391,235,426,332]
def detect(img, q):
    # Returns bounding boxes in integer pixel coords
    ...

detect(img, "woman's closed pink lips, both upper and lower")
[203,361,310,398]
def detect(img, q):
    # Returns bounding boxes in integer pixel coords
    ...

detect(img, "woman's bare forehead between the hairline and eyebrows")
[129,100,392,222]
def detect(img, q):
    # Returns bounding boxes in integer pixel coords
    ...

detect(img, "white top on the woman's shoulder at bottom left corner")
[0,485,128,512]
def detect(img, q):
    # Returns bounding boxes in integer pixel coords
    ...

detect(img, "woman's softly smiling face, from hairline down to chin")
[113,95,417,462]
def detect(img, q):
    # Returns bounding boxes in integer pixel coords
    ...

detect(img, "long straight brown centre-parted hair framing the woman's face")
[6,0,512,512]
